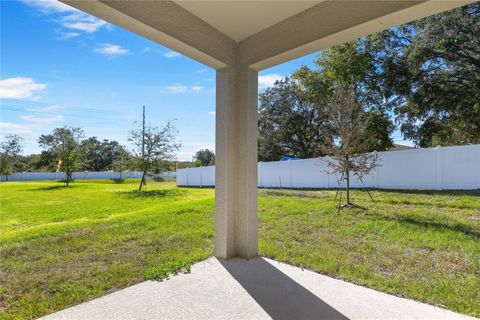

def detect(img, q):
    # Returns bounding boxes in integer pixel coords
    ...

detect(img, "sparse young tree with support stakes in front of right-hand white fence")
[323,84,393,209]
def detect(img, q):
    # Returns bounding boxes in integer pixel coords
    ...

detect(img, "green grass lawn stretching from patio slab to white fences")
[0,180,480,319]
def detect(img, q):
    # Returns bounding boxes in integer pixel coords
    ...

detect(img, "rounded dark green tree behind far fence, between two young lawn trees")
[81,137,125,171]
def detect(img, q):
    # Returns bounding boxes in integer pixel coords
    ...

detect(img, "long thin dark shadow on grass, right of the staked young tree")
[368,212,480,240]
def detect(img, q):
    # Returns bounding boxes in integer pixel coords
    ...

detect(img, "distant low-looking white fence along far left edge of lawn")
[0,171,176,181]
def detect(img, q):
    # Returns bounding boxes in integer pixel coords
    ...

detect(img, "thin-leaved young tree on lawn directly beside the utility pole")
[128,122,181,191]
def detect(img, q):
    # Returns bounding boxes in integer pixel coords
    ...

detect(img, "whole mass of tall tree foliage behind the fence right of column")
[259,2,480,161]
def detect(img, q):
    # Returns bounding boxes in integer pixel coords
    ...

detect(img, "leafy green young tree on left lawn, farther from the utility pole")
[38,126,83,187]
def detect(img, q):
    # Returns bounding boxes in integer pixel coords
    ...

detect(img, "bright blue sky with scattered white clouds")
[0,0,410,160]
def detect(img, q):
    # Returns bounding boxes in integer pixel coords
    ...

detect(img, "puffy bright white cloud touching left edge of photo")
[0,77,47,99]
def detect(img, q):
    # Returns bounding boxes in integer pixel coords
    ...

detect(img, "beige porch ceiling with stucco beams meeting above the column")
[61,0,473,71]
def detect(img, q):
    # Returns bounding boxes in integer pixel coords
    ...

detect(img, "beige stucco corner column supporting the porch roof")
[215,66,258,259]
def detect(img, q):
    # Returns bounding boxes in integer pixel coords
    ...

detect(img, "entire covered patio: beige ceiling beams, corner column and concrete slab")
[51,0,472,319]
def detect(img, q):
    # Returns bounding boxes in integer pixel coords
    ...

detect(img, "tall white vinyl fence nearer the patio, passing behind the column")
[177,145,480,190]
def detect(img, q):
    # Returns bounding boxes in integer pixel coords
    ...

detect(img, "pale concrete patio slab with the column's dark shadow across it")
[43,257,475,320]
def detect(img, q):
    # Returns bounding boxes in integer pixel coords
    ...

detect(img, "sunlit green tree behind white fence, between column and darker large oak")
[259,40,393,160]
